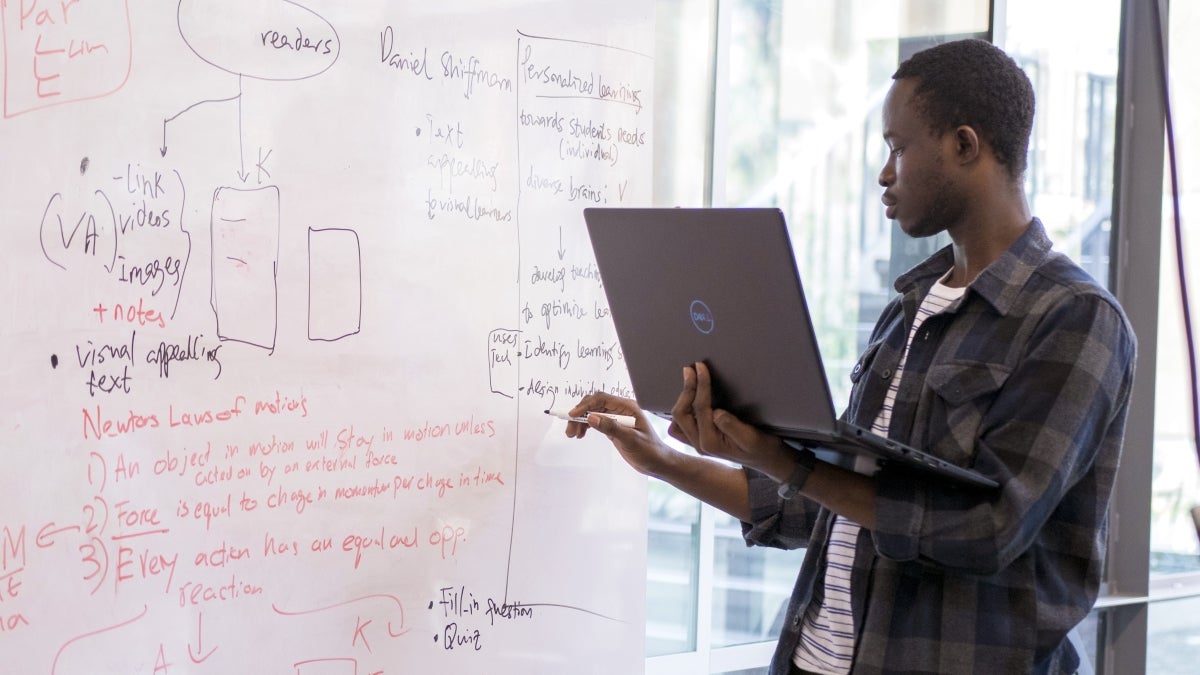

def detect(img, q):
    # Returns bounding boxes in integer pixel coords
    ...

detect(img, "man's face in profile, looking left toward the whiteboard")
[880,78,965,237]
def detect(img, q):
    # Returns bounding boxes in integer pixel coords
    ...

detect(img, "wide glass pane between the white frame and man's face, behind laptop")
[712,0,989,653]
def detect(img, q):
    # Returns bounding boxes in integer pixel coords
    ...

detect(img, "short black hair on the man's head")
[892,40,1033,179]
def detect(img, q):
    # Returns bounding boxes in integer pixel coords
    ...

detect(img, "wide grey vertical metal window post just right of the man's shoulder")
[1100,0,1165,675]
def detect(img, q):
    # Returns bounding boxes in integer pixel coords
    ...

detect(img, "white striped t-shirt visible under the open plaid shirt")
[792,273,966,675]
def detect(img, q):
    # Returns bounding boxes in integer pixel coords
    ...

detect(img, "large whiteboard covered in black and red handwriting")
[0,0,654,675]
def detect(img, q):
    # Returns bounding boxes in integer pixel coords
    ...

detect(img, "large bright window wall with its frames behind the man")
[647,0,1200,675]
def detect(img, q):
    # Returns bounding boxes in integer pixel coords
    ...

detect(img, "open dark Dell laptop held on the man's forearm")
[583,208,997,488]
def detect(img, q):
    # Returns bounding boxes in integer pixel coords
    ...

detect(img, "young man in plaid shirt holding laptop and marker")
[566,40,1135,675]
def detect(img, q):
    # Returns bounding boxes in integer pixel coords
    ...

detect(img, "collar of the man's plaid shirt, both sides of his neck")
[895,219,1054,315]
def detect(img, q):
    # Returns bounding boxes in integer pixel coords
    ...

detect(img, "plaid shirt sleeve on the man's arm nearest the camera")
[872,293,1136,574]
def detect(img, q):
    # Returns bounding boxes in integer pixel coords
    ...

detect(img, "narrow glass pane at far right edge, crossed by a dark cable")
[1150,2,1200,569]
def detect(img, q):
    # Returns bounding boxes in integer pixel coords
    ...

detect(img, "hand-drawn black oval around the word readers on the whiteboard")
[176,0,342,80]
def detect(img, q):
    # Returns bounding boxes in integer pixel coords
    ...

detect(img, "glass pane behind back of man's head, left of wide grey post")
[1002,0,1121,286]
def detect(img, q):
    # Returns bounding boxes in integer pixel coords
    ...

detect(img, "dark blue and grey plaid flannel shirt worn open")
[743,219,1136,675]
